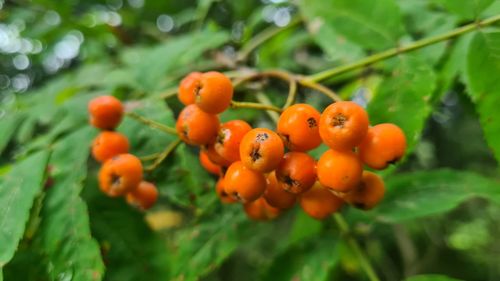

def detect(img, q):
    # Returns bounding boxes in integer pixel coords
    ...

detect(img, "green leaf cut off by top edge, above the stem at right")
[434,0,494,20]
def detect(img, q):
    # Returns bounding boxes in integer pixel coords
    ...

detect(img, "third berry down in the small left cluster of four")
[99,154,142,197]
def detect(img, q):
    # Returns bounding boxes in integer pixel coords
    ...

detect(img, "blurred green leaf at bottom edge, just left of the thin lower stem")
[263,235,340,281]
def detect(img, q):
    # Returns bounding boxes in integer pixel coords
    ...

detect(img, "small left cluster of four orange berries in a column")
[88,96,158,210]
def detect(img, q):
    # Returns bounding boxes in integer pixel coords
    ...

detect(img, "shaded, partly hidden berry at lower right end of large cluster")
[341,171,385,210]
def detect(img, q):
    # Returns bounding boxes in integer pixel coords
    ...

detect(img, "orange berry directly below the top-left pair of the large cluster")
[175,104,219,145]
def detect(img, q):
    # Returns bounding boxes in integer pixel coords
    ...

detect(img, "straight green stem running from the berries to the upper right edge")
[305,15,500,82]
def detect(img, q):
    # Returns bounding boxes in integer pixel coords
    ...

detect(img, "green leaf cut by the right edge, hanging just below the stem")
[467,31,500,161]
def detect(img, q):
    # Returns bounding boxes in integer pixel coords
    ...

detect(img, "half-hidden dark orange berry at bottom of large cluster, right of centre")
[299,182,343,220]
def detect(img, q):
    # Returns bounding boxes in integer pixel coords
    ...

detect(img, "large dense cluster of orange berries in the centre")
[176,71,406,220]
